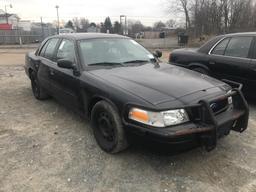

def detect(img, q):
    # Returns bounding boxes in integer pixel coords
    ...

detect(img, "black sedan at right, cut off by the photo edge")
[169,33,256,91]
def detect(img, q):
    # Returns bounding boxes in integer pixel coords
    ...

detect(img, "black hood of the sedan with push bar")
[87,63,224,105]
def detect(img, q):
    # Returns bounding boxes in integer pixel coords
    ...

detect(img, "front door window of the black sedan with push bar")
[57,39,76,62]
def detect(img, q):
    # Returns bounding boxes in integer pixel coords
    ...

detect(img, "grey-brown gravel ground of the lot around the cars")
[0,50,256,192]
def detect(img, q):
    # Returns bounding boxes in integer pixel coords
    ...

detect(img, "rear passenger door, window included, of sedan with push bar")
[37,38,59,93]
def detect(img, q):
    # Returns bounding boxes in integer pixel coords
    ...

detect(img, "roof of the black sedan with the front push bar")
[50,33,128,40]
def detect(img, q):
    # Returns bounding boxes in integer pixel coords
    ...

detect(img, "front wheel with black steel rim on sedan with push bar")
[91,101,128,154]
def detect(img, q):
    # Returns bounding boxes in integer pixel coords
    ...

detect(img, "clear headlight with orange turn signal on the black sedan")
[129,108,189,127]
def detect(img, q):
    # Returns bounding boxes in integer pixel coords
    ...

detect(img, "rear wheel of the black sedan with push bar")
[30,71,49,100]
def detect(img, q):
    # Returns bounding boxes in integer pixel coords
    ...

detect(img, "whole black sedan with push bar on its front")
[25,34,249,153]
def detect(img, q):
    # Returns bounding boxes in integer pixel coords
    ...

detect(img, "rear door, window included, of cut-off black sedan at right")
[209,36,253,83]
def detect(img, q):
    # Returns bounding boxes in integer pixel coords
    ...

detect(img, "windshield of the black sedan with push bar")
[79,38,155,65]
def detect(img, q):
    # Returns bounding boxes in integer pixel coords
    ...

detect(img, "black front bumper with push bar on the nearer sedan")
[125,80,249,151]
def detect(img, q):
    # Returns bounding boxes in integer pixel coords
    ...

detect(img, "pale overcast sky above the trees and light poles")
[0,0,181,25]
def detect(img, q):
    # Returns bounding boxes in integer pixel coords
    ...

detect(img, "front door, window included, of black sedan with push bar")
[47,39,81,110]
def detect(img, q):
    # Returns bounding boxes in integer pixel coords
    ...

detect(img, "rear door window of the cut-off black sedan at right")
[225,37,252,58]
